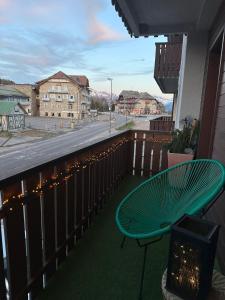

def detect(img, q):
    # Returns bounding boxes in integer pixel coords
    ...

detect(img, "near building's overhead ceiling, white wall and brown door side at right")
[112,0,225,274]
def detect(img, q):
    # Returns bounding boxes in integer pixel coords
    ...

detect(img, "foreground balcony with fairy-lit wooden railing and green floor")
[0,131,171,299]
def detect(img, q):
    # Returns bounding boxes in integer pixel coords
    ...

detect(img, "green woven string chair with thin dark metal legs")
[116,159,225,299]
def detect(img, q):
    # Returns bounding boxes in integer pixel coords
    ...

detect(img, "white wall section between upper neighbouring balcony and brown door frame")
[175,32,208,128]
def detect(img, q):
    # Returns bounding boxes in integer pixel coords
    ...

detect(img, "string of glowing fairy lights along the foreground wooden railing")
[3,137,129,210]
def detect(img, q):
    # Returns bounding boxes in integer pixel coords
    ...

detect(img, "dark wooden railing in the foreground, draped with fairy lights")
[0,131,171,300]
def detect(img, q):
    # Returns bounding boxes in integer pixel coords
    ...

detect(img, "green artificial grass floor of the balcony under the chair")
[38,176,168,300]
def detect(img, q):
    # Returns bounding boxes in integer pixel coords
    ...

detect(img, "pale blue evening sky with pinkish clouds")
[0,0,172,99]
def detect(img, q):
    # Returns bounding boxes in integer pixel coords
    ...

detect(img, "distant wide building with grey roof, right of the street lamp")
[115,91,164,115]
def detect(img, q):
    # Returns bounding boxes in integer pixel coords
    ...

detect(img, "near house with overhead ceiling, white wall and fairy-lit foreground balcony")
[0,0,225,300]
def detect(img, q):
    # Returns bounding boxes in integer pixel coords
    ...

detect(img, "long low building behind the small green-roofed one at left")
[0,85,32,115]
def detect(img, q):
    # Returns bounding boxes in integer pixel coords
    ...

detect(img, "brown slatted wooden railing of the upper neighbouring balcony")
[154,43,182,78]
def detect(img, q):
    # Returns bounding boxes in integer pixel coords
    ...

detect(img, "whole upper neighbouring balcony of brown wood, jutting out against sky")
[154,43,182,93]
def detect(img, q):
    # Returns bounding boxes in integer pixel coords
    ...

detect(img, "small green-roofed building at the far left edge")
[0,101,27,131]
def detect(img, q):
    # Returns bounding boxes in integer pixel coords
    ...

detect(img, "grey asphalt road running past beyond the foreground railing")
[0,115,126,180]
